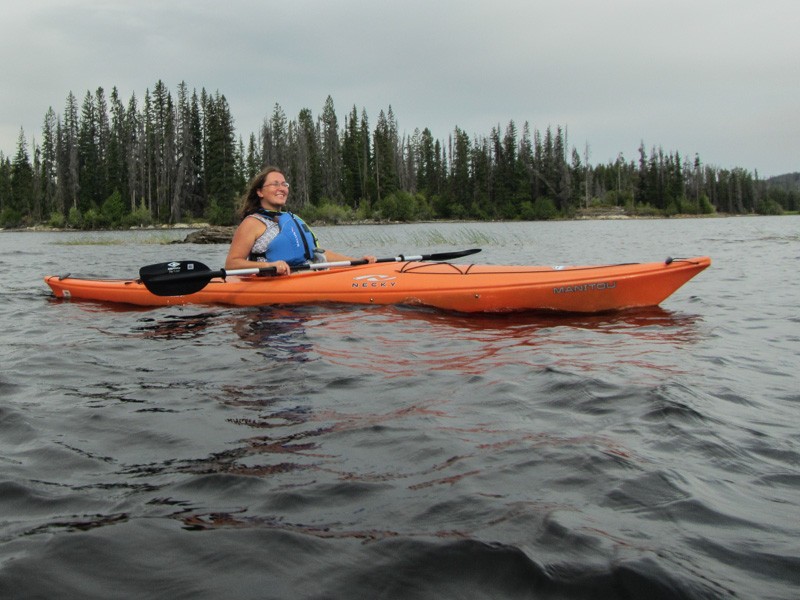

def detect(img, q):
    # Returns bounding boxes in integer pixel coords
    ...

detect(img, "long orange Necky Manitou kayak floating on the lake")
[45,256,711,313]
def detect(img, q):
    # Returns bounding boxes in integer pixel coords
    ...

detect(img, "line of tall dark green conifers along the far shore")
[0,81,800,229]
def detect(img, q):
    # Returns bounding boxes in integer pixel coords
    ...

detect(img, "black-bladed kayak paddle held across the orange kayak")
[139,248,481,296]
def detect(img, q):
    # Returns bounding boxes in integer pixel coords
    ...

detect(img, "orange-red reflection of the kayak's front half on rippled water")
[296,307,698,377]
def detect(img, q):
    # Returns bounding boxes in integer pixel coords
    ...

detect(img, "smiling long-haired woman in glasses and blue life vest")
[225,167,375,275]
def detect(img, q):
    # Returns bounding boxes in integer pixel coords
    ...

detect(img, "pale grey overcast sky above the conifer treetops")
[0,0,800,177]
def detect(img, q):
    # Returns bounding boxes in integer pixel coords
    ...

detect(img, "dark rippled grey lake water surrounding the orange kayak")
[0,216,800,600]
